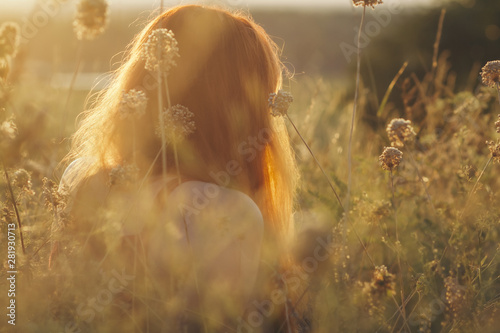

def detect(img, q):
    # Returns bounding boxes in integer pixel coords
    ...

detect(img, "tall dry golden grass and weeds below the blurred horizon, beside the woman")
[0,2,500,333]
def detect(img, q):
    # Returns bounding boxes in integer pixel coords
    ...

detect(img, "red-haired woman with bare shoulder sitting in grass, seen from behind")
[51,6,308,332]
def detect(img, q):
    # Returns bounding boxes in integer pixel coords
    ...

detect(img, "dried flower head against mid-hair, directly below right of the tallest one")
[156,104,196,143]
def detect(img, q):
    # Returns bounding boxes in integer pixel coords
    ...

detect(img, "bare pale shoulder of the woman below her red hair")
[168,181,263,223]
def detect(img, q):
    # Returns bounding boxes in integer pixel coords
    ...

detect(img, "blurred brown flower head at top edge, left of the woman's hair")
[73,0,108,40]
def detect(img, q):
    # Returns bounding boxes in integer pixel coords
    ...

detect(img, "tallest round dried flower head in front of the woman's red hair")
[142,29,180,75]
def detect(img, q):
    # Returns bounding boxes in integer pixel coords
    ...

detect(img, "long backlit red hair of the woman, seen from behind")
[67,5,297,242]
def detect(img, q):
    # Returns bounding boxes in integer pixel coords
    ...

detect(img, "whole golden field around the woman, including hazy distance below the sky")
[0,0,500,333]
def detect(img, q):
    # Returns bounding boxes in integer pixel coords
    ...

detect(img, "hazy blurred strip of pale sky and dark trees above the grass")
[0,0,500,94]
